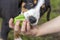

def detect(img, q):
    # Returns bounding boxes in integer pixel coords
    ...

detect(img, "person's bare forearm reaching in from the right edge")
[36,16,60,36]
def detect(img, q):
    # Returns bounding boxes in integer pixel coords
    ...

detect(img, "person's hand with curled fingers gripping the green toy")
[9,18,37,36]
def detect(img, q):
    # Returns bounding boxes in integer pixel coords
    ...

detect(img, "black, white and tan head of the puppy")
[21,0,51,25]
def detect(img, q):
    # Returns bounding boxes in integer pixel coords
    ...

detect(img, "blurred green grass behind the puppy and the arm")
[0,0,60,40]
